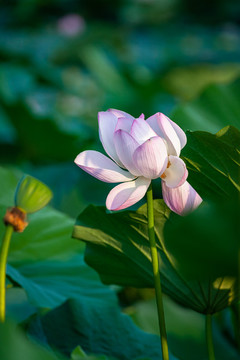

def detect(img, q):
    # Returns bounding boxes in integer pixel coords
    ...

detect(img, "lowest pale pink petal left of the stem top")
[106,177,151,210]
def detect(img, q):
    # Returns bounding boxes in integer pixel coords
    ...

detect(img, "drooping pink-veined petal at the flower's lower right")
[162,181,202,215]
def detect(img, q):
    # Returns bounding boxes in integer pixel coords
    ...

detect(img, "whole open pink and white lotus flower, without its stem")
[75,109,202,215]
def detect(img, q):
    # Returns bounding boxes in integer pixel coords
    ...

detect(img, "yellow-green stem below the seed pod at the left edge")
[0,225,13,322]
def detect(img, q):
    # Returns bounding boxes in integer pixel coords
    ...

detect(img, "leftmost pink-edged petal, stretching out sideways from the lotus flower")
[74,150,135,183]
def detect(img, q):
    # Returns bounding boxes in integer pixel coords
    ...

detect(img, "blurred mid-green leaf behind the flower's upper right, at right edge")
[172,80,240,133]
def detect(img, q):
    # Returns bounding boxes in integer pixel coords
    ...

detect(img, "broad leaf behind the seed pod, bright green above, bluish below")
[0,168,116,308]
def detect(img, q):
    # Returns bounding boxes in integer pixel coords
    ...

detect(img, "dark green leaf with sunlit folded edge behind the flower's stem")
[73,200,234,313]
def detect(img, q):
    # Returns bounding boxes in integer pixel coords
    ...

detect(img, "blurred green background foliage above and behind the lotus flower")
[0,0,240,216]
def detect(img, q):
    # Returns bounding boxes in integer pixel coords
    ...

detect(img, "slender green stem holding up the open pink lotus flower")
[147,184,169,360]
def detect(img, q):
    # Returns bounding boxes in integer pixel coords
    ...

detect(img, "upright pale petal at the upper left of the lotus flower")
[98,111,122,166]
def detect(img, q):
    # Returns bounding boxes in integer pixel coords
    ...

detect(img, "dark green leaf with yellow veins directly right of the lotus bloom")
[181,126,240,201]
